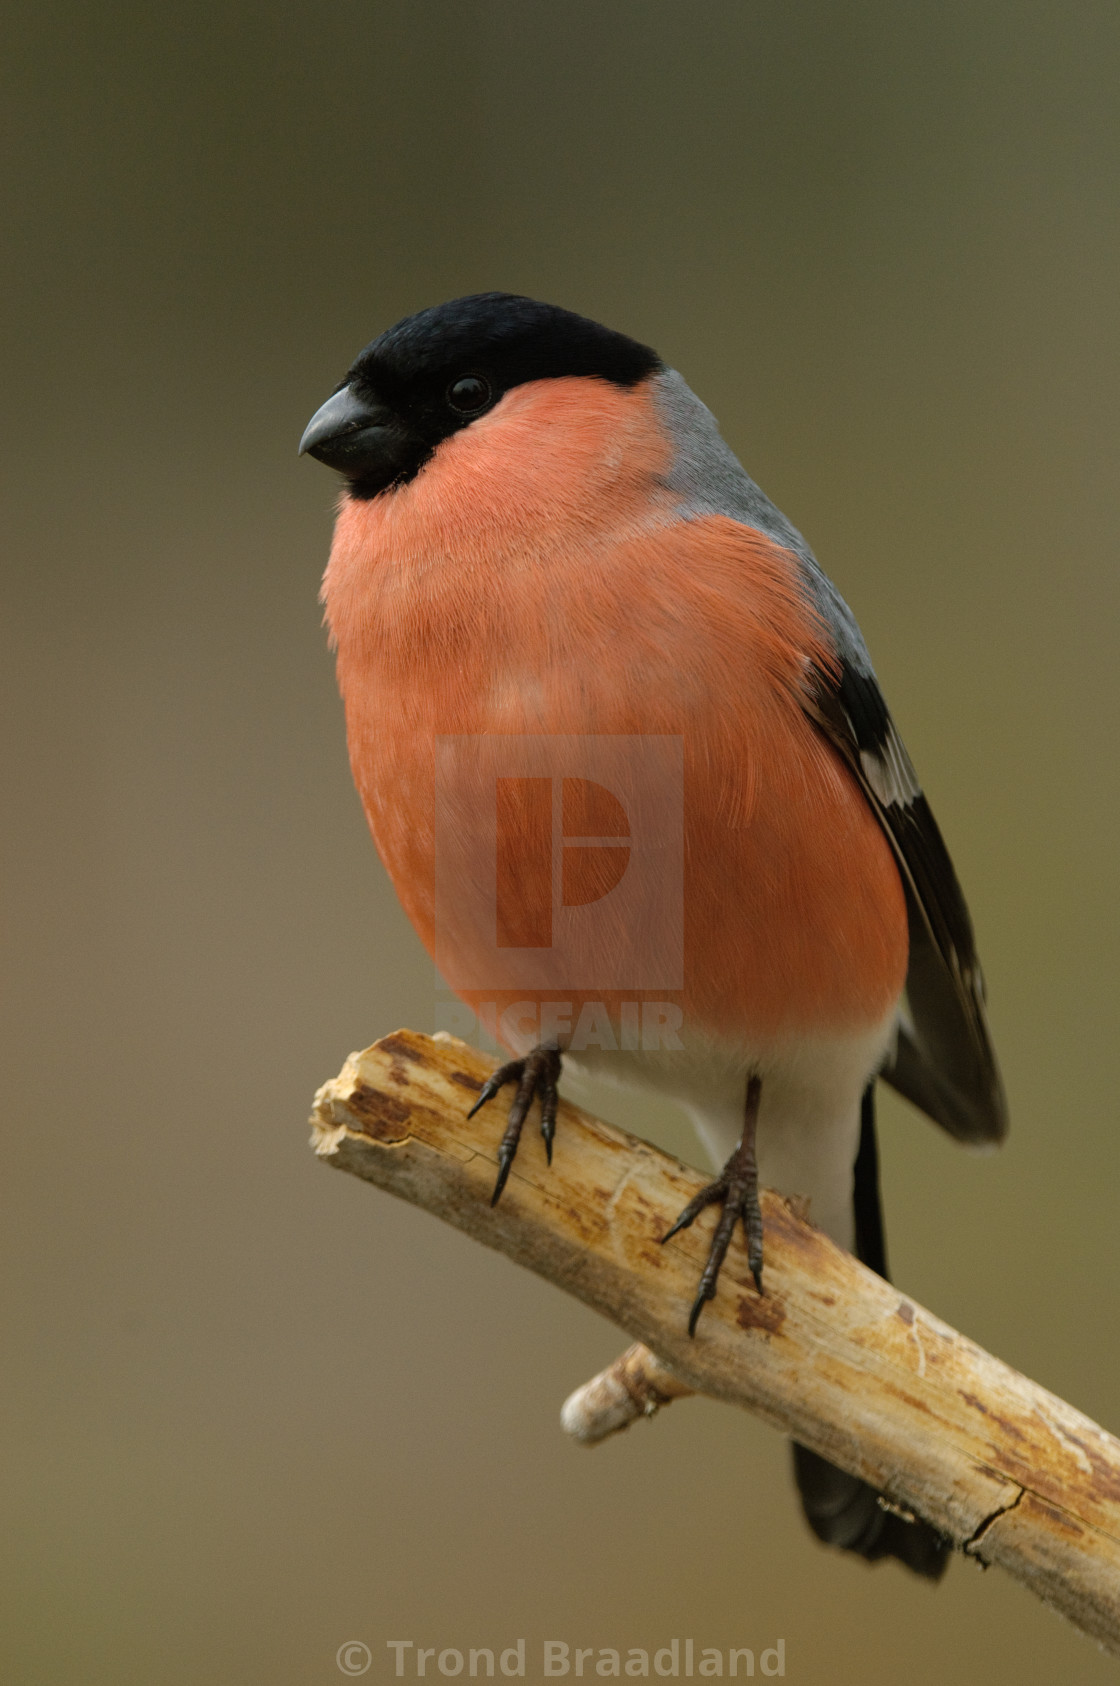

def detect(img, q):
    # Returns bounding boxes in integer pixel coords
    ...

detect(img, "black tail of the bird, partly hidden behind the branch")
[793,1082,951,1580]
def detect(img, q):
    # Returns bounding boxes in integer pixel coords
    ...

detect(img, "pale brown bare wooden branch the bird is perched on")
[312,1030,1120,1654]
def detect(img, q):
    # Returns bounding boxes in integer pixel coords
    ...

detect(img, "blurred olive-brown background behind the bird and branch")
[0,0,1120,1686]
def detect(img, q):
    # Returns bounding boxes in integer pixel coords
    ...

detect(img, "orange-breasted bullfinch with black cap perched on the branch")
[300,292,1007,1580]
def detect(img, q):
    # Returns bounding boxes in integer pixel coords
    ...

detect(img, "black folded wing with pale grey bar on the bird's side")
[808,658,1007,1141]
